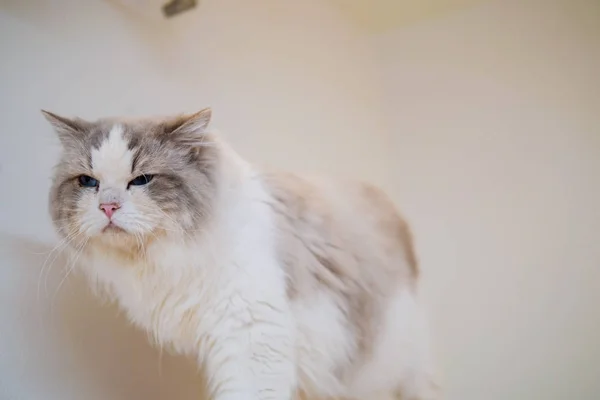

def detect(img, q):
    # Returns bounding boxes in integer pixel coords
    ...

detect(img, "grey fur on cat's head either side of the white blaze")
[44,109,219,242]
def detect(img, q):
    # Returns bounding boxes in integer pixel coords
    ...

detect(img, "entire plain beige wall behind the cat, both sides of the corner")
[0,0,600,400]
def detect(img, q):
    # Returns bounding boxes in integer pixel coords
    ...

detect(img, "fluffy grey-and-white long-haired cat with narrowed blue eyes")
[44,109,437,400]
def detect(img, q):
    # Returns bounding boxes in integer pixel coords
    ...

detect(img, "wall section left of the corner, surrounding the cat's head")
[0,0,389,400]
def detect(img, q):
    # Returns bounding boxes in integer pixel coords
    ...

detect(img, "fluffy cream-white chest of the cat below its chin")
[87,244,223,351]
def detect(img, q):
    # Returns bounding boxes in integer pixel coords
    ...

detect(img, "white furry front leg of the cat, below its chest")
[203,292,296,400]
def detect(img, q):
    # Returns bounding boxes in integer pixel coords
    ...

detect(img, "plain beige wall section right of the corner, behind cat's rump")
[374,0,600,400]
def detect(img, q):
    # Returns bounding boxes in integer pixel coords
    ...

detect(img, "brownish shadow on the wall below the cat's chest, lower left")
[0,235,209,400]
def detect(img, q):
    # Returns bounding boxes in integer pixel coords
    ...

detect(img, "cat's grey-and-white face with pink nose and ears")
[44,109,217,245]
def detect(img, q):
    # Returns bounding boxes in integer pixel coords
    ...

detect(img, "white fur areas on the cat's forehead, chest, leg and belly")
[72,130,433,400]
